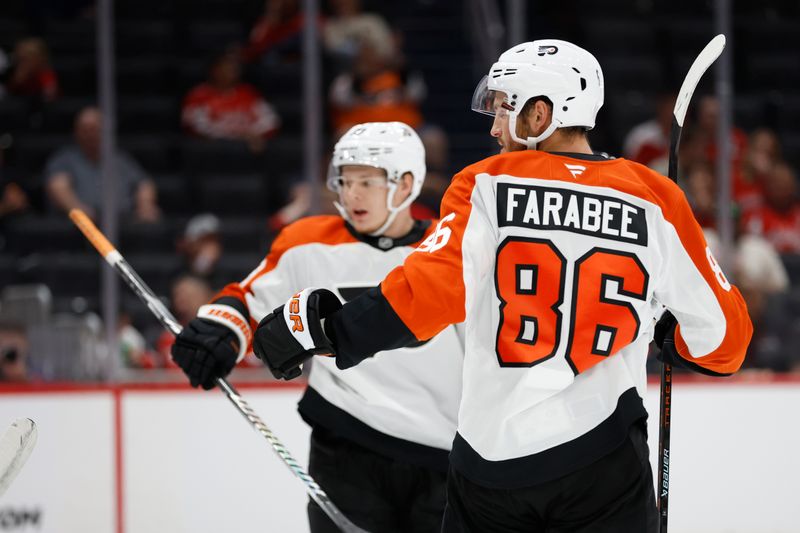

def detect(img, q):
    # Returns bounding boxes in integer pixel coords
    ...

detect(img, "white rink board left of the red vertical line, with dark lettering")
[0,392,116,533]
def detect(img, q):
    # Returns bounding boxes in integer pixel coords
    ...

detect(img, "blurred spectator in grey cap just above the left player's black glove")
[178,213,223,288]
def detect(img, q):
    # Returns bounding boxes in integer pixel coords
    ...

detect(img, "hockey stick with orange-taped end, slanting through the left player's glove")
[69,209,368,533]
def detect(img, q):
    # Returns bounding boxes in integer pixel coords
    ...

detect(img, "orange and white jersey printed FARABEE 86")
[329,151,752,488]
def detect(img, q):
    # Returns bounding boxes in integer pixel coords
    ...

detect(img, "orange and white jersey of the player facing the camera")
[215,216,464,470]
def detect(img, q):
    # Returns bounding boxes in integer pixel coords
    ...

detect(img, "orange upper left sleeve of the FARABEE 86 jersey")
[381,171,475,340]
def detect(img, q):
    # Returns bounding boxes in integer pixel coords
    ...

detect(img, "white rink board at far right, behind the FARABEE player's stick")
[647,383,800,533]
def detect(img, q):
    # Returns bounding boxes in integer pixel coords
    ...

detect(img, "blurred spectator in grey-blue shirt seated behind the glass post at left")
[45,107,161,222]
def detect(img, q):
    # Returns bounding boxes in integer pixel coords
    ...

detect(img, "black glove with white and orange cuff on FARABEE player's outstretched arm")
[253,288,342,380]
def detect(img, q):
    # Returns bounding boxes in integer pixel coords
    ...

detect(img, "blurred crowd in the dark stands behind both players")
[0,0,800,381]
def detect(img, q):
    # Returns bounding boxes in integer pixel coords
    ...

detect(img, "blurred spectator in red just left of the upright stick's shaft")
[622,94,675,168]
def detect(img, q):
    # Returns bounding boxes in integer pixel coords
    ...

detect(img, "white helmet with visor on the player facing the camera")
[328,122,426,236]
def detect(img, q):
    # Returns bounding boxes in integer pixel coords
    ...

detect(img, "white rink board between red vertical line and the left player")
[122,389,309,533]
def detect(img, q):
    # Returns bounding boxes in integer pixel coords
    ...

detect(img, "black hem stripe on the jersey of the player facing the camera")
[297,387,449,473]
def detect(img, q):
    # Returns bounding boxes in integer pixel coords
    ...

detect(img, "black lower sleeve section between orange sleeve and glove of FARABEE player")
[325,286,417,370]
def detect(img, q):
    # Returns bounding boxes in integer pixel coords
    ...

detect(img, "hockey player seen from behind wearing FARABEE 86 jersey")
[254,40,752,533]
